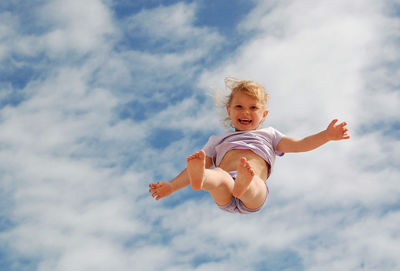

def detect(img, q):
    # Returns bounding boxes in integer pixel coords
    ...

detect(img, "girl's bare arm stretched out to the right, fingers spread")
[276,119,350,152]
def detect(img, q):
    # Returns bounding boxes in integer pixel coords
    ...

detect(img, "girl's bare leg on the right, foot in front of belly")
[232,157,267,212]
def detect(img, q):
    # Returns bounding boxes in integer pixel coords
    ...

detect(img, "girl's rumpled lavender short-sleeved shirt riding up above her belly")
[203,127,284,177]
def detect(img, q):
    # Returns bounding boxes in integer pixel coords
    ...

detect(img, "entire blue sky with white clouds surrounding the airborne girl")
[0,0,400,271]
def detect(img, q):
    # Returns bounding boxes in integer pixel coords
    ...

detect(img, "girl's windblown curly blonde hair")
[217,77,269,127]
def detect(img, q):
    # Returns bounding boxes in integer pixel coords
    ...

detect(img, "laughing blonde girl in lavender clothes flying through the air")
[149,79,350,214]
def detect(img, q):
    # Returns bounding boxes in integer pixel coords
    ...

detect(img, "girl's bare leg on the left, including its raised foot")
[186,150,234,205]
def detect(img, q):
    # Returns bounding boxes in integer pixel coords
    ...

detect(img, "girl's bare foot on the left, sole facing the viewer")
[186,150,206,190]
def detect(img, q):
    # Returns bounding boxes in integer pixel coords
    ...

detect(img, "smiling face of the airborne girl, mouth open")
[226,92,268,131]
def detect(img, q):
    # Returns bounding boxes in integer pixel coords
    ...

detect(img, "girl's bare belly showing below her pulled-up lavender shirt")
[219,150,268,180]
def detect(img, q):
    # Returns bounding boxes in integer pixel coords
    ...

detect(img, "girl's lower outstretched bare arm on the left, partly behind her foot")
[149,154,213,200]
